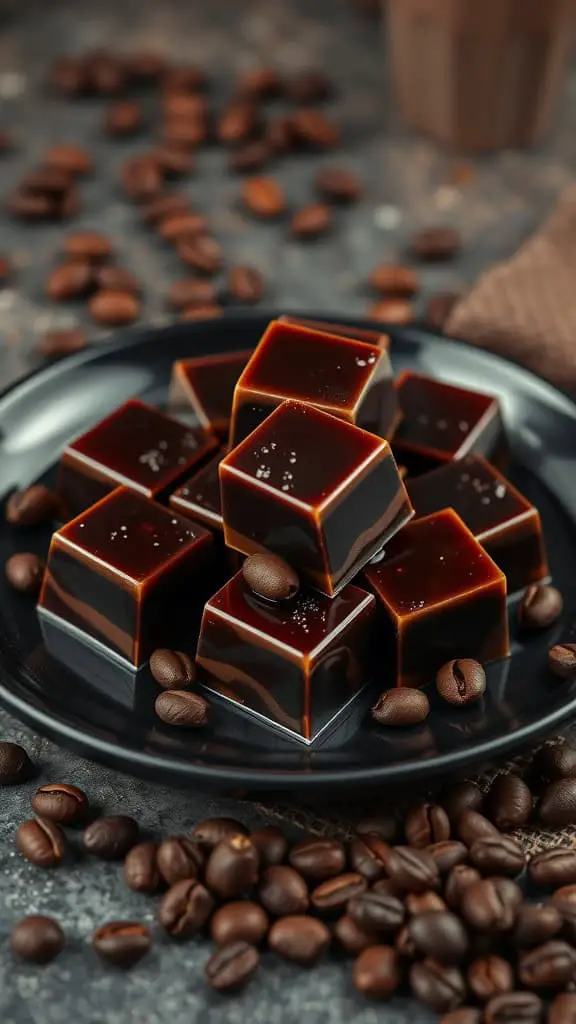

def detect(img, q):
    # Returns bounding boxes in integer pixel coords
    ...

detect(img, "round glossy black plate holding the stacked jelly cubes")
[0,313,576,793]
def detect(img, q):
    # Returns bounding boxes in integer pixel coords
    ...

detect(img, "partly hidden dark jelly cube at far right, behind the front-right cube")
[407,455,549,594]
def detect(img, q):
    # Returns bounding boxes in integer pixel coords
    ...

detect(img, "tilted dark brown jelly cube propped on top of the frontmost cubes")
[219,401,413,596]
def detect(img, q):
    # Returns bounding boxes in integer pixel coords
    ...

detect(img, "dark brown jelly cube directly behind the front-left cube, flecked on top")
[57,399,217,519]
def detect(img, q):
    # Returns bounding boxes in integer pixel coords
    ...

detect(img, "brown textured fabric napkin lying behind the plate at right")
[444,186,576,391]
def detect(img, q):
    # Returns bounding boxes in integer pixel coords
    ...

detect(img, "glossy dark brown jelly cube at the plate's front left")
[40,487,212,667]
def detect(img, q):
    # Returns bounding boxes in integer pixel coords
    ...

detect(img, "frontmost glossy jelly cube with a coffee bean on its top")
[197,572,375,742]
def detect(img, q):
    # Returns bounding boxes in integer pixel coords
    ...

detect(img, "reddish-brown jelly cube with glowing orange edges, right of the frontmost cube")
[361,509,509,686]
